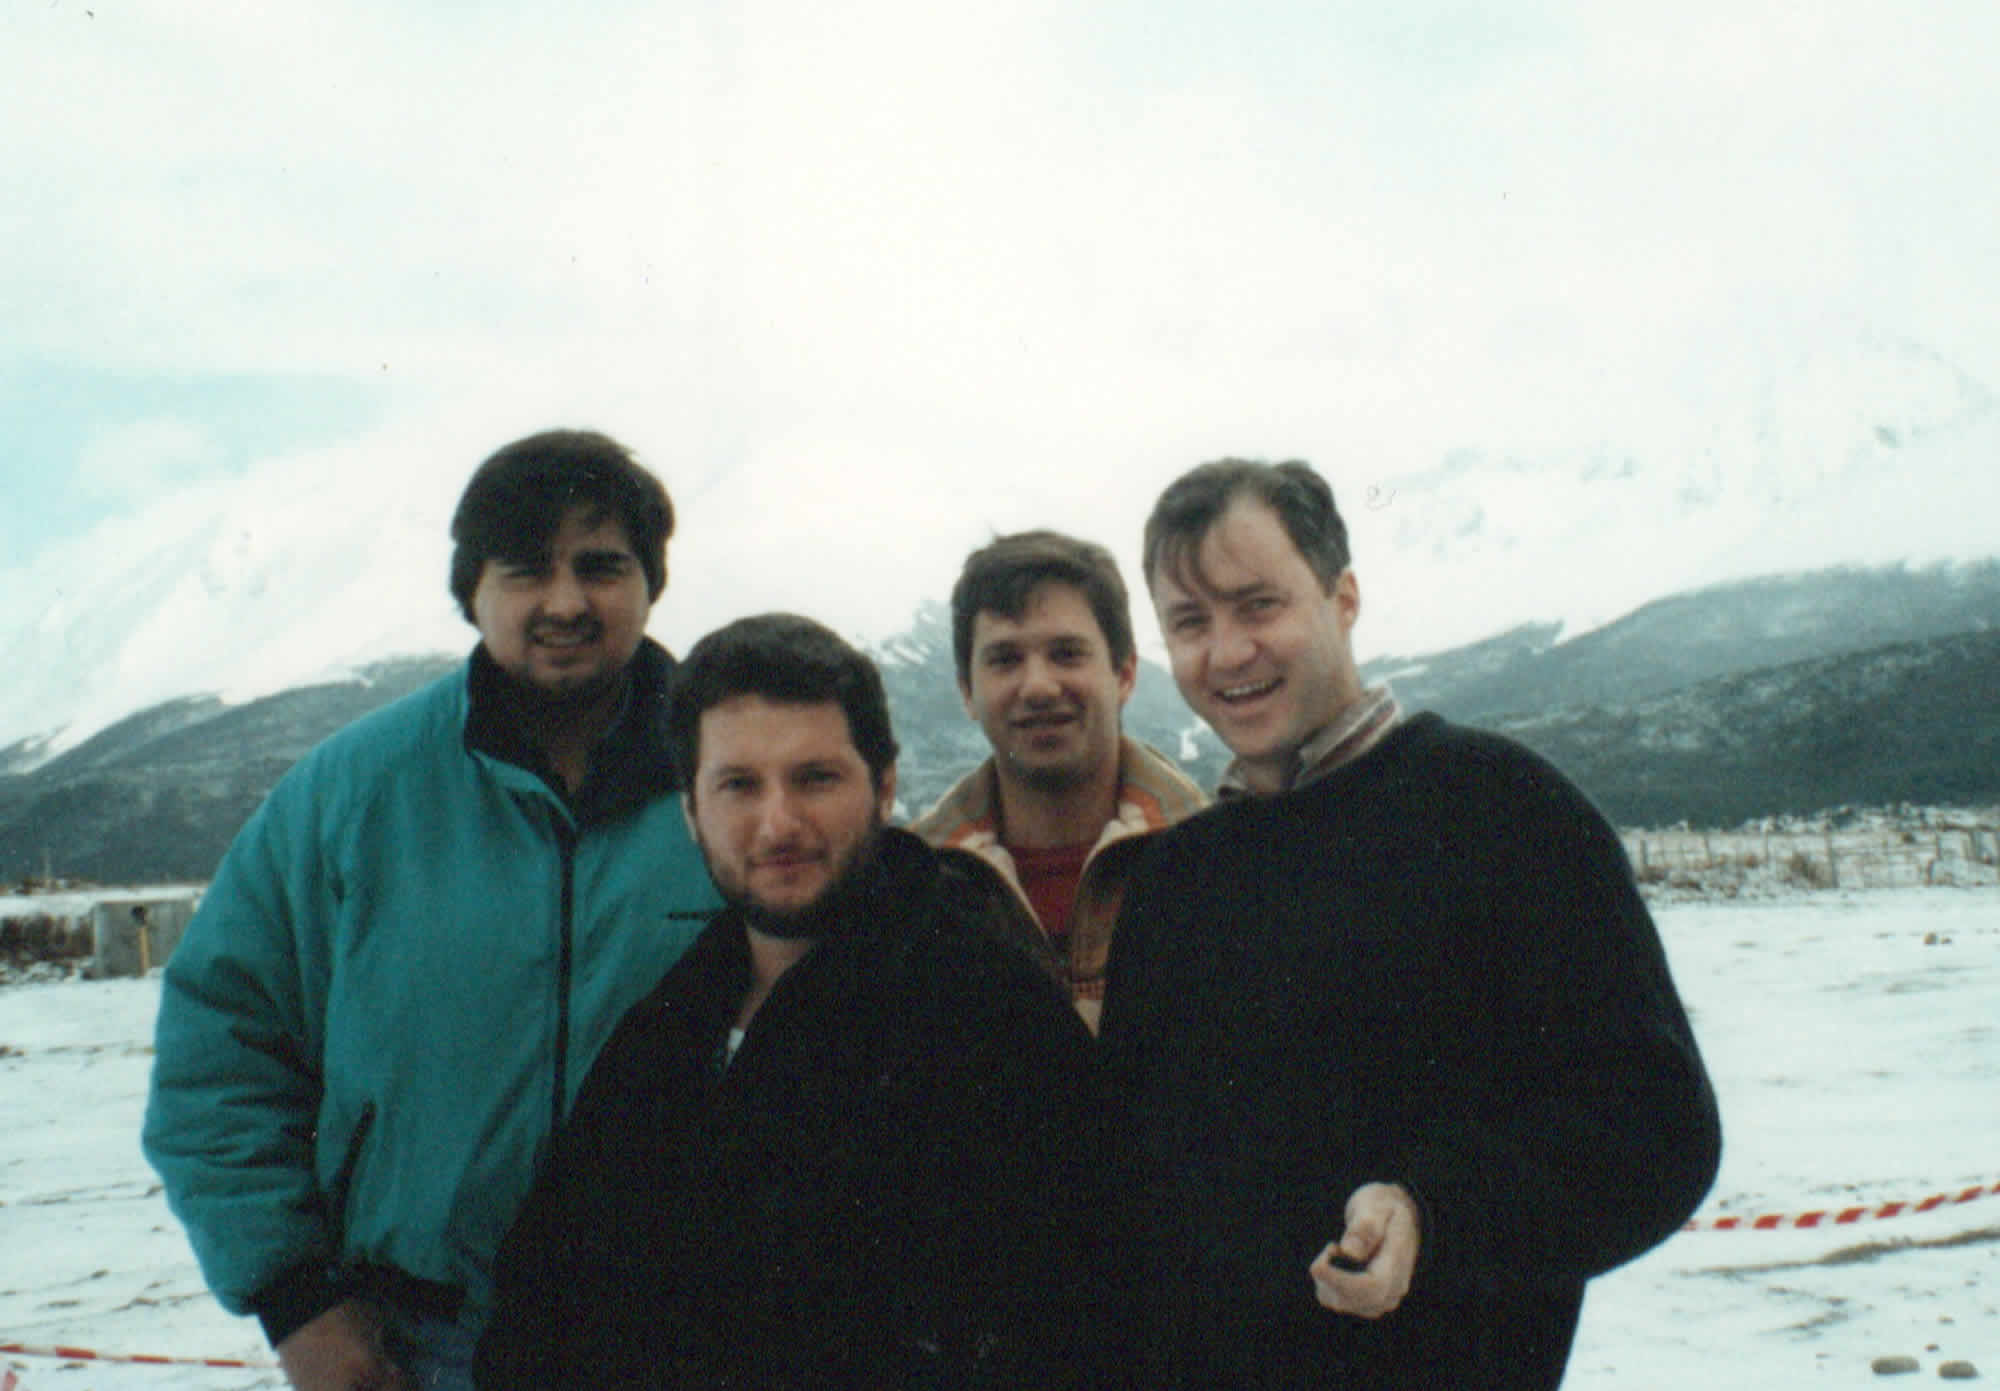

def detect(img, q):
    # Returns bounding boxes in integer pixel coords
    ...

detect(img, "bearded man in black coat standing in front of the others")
[476,614,1118,1391]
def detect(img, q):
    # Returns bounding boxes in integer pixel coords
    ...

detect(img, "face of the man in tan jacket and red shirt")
[958,582,1138,791]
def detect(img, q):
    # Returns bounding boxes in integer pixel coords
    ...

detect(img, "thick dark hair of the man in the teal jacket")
[452,430,674,622]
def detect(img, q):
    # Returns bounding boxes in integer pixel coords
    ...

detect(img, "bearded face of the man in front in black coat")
[686,696,896,935]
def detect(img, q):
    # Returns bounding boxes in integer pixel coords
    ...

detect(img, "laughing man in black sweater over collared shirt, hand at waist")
[1102,460,1720,1391]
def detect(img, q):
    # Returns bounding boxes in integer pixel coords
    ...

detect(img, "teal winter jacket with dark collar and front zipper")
[144,642,720,1341]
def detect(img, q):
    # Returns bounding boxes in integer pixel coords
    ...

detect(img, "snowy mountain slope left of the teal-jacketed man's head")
[0,456,472,771]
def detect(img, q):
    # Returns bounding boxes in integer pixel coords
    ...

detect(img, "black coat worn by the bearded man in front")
[476,831,1116,1389]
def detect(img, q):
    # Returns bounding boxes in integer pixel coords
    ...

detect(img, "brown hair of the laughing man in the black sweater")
[1144,460,1352,592]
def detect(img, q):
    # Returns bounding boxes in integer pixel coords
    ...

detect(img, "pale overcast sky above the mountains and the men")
[0,0,2000,683]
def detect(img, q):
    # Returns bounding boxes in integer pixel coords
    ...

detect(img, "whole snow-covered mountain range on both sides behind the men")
[0,336,2000,771]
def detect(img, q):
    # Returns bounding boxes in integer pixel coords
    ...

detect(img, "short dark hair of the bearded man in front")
[666,614,896,787]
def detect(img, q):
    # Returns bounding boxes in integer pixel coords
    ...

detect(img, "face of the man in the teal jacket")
[472,506,652,703]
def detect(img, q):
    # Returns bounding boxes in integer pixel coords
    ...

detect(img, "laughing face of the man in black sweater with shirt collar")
[1152,498,1362,793]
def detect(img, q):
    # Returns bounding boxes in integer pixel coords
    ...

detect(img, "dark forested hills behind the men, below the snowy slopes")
[0,562,2000,881]
